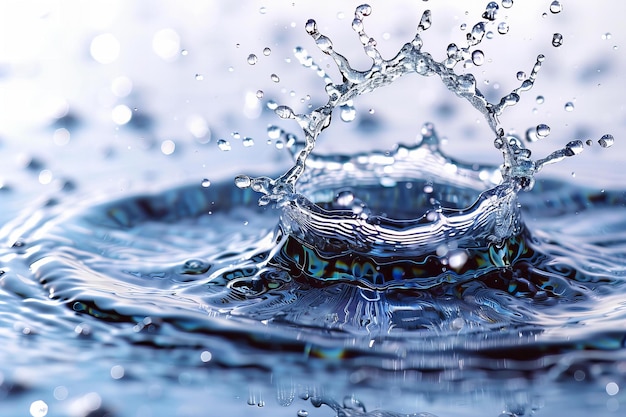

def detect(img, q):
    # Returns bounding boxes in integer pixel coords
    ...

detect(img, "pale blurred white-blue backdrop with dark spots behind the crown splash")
[0,0,626,224]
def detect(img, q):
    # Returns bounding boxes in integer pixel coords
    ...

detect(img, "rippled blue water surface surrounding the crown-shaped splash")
[0,4,626,417]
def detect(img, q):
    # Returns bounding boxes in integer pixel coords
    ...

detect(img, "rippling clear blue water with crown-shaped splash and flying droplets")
[0,1,626,417]
